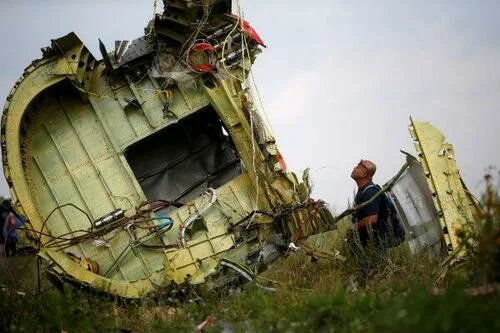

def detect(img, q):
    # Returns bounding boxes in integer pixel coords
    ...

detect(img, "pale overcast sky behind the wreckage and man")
[0,0,500,210]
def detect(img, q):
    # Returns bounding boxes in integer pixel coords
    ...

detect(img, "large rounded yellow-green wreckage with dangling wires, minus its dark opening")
[2,1,333,298]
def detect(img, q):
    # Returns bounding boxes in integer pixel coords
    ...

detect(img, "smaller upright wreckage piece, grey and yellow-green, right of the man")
[380,119,481,261]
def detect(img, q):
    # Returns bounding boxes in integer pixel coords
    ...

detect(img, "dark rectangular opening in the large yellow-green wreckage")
[125,108,243,202]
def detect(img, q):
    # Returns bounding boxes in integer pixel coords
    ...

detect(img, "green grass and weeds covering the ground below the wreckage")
[0,206,500,333]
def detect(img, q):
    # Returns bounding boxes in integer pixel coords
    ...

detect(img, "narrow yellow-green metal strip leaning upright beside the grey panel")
[409,119,478,251]
